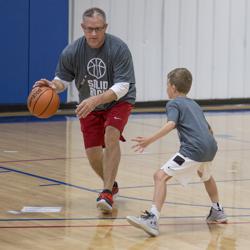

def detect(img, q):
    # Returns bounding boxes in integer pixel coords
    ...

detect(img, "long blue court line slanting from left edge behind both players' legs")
[0,166,250,210]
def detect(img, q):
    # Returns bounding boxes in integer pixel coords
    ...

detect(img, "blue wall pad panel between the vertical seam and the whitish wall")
[29,0,68,102]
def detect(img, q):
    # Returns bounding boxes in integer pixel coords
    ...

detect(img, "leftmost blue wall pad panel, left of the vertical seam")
[0,0,29,104]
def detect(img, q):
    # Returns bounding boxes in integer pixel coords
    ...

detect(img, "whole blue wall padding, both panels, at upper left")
[0,0,68,105]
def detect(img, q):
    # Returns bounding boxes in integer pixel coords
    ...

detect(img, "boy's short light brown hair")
[168,68,192,94]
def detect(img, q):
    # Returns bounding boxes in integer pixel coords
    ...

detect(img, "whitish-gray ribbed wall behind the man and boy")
[68,0,250,101]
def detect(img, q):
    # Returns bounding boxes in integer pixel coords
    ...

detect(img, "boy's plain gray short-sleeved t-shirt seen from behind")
[166,97,217,162]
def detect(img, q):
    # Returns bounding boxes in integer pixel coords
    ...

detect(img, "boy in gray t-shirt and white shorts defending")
[127,68,227,236]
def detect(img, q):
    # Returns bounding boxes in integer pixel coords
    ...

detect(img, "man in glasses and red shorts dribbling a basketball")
[35,8,136,213]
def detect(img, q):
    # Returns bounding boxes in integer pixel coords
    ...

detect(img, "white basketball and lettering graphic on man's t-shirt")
[87,58,108,96]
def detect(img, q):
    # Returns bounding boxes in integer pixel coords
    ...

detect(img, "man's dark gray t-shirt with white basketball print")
[56,34,136,110]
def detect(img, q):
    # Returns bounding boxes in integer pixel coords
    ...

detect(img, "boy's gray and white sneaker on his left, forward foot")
[127,211,160,236]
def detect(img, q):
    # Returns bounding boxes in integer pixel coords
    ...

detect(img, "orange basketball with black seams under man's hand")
[27,86,60,118]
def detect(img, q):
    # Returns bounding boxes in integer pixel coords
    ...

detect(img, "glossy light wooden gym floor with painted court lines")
[0,106,250,250]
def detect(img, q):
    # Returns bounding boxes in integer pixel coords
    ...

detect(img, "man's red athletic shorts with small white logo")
[80,102,133,148]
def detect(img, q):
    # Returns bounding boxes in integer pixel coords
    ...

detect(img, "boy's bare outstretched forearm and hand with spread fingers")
[132,121,175,153]
